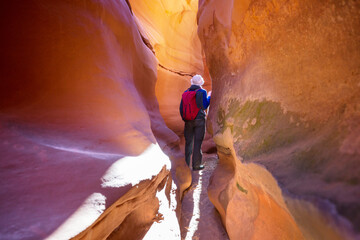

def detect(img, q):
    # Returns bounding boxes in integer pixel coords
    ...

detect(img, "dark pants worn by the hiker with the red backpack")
[184,119,205,168]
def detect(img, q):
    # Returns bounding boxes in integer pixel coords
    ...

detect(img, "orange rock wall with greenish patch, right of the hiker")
[198,0,360,239]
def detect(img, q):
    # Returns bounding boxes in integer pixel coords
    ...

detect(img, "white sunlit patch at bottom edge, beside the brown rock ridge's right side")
[143,181,181,240]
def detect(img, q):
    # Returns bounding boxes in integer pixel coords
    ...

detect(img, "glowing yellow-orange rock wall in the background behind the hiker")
[130,0,211,135]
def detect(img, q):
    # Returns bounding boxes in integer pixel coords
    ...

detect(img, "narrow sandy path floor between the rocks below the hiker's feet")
[180,154,229,240]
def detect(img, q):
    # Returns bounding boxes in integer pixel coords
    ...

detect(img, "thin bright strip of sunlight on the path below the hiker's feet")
[185,171,202,240]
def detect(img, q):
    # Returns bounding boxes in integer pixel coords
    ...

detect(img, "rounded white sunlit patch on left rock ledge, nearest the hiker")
[101,144,171,187]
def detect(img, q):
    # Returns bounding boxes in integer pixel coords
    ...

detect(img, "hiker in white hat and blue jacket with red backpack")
[180,74,211,170]
